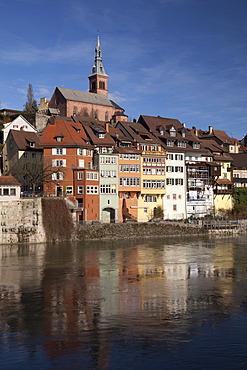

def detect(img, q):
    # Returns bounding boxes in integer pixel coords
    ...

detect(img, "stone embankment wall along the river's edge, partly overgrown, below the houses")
[0,198,247,244]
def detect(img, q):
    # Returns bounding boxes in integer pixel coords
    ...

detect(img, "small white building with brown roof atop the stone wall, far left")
[0,176,21,201]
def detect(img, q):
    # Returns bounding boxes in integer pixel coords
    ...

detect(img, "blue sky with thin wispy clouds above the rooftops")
[0,0,247,139]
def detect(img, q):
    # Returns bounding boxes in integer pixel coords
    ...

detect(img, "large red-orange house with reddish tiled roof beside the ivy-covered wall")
[40,117,99,221]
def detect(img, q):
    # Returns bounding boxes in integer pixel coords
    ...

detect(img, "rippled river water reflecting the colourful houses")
[0,237,247,369]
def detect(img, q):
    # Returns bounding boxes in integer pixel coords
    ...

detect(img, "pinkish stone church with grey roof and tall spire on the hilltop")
[49,37,128,122]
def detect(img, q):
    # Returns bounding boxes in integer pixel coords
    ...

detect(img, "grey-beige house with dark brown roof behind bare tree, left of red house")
[2,130,44,196]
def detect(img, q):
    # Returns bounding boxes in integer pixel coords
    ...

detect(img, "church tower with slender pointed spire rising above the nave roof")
[88,36,108,98]
